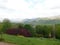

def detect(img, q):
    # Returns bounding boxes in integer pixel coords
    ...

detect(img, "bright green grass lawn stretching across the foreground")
[0,34,60,45]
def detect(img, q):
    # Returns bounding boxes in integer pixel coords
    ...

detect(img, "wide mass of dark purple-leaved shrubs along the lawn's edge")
[6,28,31,37]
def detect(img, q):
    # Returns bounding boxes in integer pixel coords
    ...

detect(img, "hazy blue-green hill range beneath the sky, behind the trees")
[23,16,60,25]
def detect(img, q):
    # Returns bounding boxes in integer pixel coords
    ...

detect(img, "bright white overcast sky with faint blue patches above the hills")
[0,0,60,20]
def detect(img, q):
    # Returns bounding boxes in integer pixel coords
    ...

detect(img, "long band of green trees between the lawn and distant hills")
[0,19,60,39]
